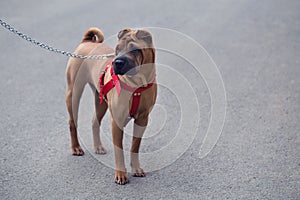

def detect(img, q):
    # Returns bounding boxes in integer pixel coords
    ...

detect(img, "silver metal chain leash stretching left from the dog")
[0,19,114,60]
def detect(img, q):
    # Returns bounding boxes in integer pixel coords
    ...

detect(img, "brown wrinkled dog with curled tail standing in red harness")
[66,27,157,185]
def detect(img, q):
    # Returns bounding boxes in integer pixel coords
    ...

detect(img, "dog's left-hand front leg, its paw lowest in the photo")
[111,117,129,185]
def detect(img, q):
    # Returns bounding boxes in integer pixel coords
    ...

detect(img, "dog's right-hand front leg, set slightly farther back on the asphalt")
[130,115,148,177]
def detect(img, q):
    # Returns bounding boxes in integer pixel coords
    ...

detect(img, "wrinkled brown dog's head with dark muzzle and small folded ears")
[113,29,155,75]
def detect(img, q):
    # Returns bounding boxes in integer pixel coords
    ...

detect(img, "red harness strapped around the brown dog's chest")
[99,61,153,117]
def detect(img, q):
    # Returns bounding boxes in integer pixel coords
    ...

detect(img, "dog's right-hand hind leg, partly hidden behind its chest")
[92,91,108,154]
